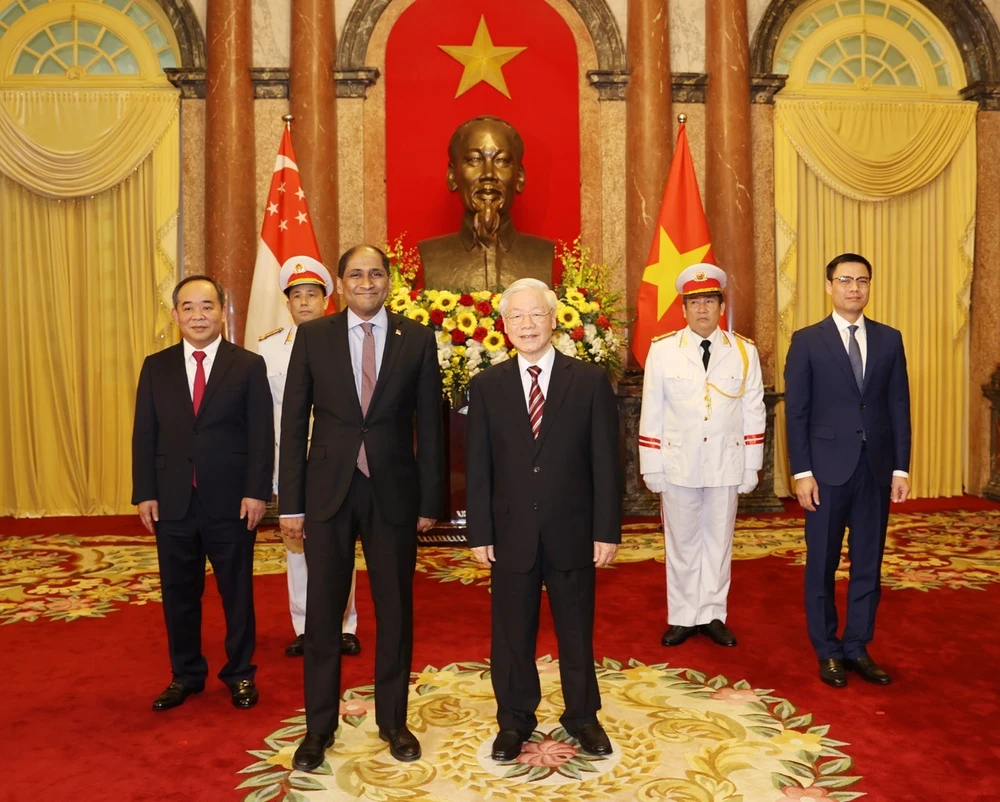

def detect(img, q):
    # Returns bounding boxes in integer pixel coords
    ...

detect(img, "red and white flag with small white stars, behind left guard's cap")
[243,123,334,350]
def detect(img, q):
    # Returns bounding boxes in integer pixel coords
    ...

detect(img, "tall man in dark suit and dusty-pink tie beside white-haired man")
[278,245,444,771]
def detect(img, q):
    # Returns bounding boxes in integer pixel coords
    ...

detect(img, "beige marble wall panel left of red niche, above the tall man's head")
[337,98,368,253]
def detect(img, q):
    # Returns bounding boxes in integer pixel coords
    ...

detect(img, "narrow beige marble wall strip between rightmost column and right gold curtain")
[750,103,778,385]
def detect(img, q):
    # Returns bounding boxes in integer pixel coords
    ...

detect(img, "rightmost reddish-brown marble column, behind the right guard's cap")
[704,0,754,337]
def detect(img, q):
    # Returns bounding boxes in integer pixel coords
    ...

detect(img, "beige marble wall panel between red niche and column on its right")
[600,102,635,296]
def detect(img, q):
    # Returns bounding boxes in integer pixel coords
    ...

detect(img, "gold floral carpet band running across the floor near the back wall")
[0,510,1000,624]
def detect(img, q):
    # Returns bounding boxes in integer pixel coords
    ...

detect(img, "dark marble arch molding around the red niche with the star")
[340,0,628,100]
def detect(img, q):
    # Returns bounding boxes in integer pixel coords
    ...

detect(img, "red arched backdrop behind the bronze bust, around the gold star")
[385,0,584,278]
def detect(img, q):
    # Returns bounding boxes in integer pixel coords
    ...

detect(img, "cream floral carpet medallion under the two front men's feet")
[232,657,864,802]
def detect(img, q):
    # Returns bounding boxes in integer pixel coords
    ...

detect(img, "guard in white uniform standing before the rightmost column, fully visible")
[639,264,764,646]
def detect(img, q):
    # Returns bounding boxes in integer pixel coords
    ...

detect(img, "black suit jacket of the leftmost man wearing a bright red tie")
[132,340,274,521]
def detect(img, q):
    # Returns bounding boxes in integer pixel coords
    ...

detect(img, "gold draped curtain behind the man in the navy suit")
[774,98,977,497]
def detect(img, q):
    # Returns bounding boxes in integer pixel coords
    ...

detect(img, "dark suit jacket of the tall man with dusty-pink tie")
[278,312,444,526]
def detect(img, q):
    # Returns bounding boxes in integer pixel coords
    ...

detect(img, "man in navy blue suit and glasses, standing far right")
[785,253,910,688]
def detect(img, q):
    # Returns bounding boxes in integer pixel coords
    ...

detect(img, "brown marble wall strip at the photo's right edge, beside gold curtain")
[966,111,1000,494]
